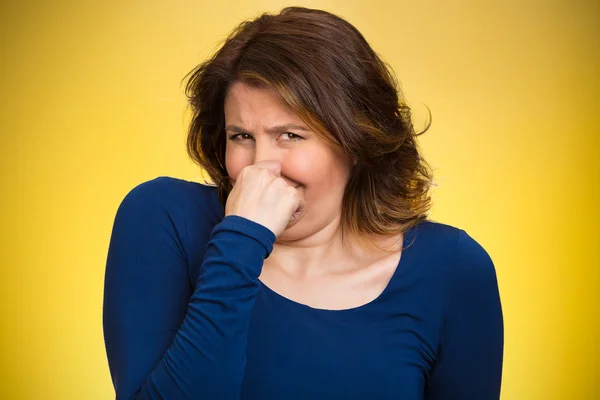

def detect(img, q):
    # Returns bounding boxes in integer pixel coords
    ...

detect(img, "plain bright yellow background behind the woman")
[0,0,600,400]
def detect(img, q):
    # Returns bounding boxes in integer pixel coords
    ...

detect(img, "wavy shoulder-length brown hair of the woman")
[184,7,432,245]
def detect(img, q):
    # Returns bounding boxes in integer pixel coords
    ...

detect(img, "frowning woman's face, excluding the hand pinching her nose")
[225,82,351,241]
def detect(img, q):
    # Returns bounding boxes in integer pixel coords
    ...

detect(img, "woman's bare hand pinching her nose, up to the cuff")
[225,161,304,237]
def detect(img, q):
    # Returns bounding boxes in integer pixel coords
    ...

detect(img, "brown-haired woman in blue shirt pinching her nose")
[103,7,503,400]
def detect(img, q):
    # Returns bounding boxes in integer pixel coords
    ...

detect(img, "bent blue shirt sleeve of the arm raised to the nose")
[103,182,276,400]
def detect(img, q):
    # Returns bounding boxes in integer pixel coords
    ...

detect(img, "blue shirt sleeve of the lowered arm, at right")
[425,230,504,400]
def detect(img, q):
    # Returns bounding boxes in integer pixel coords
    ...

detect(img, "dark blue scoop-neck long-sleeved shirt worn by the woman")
[102,177,504,400]
